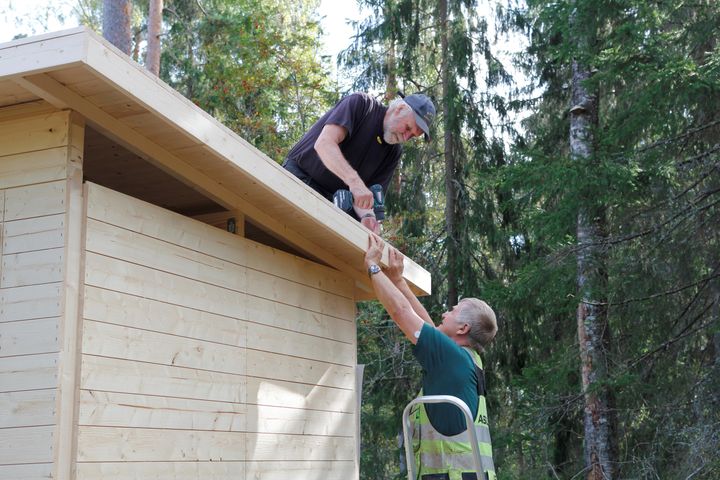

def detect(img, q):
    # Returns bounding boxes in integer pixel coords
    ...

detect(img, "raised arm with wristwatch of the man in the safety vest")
[365,235,432,344]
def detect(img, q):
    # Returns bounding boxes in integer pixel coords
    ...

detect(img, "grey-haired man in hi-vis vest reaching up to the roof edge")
[365,234,497,480]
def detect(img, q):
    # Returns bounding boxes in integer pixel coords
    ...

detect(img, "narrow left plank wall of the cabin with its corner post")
[0,107,82,480]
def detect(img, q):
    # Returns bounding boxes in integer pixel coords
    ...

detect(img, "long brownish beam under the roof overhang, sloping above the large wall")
[15,74,376,292]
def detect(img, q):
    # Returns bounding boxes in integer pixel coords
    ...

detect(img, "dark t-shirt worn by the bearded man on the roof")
[287,93,402,194]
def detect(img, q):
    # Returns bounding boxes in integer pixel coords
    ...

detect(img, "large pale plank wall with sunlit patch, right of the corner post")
[77,184,357,480]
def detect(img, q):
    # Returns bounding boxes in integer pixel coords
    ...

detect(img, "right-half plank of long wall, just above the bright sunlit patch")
[247,349,355,389]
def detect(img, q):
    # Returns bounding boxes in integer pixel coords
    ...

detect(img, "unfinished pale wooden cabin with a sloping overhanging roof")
[0,28,430,480]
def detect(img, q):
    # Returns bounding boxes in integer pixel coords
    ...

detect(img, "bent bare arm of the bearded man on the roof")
[315,124,373,210]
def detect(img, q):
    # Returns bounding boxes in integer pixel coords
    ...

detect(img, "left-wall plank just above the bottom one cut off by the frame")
[0,426,55,465]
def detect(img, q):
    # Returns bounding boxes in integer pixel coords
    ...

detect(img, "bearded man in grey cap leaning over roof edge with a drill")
[283,93,435,233]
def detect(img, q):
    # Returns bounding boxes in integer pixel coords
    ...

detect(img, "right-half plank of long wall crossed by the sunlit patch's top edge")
[246,377,355,413]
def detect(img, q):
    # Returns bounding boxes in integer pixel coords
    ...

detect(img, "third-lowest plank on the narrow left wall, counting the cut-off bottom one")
[0,389,56,428]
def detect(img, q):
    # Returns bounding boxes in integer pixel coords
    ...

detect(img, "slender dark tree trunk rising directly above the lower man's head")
[438,0,458,308]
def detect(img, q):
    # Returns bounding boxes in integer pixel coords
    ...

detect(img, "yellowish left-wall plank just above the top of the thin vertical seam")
[0,146,67,188]
